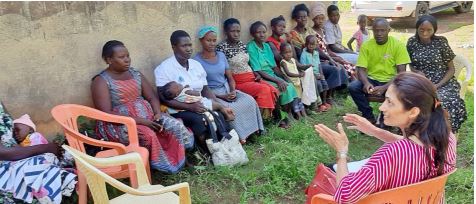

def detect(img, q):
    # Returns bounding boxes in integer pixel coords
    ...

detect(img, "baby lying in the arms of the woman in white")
[162,81,235,121]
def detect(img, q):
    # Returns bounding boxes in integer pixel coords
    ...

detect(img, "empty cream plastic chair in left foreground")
[62,145,191,204]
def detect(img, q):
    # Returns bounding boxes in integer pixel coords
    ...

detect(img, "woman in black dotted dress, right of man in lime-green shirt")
[407,15,467,133]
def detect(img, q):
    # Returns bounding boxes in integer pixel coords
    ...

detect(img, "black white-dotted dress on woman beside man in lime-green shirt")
[407,36,467,132]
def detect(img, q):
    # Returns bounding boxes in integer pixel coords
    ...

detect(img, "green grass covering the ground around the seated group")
[65,90,474,203]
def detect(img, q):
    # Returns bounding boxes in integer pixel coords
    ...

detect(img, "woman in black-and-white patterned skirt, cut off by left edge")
[0,103,77,204]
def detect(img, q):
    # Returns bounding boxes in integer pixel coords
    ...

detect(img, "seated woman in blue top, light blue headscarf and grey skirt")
[193,26,264,144]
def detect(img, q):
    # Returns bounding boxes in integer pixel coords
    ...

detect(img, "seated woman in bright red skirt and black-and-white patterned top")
[216,18,279,124]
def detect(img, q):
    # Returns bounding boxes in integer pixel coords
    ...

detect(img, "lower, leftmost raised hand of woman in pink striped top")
[314,123,349,152]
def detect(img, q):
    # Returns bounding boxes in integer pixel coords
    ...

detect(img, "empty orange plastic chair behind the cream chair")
[51,104,151,204]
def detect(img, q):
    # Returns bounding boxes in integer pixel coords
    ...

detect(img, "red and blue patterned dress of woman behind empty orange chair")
[94,68,194,173]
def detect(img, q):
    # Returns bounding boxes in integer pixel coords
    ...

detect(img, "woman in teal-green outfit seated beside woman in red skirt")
[246,21,298,128]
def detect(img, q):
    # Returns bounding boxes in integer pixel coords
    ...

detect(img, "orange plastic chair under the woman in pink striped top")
[311,169,456,204]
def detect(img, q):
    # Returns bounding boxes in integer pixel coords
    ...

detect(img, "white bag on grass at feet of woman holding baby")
[205,112,248,166]
